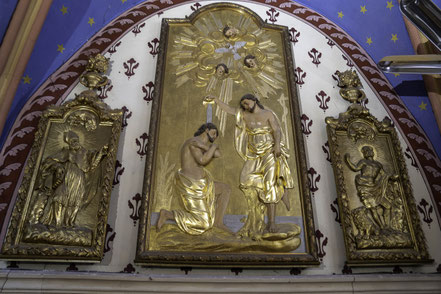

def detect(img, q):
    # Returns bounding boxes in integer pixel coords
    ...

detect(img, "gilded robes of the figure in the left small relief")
[34,147,104,227]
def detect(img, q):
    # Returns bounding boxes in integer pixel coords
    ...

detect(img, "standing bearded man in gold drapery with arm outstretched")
[206,94,294,234]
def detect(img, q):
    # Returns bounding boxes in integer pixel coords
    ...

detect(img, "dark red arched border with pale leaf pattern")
[0,0,441,236]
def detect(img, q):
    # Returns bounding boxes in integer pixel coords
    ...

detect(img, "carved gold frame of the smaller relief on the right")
[326,104,433,266]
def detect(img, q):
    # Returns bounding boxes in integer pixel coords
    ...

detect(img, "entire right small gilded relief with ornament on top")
[326,70,433,266]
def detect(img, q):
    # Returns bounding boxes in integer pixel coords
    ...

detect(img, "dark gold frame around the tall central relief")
[135,3,319,267]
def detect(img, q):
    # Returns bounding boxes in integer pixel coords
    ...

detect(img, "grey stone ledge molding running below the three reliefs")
[0,270,441,293]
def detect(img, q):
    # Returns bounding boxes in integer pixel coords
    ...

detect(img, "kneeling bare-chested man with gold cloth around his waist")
[156,123,231,235]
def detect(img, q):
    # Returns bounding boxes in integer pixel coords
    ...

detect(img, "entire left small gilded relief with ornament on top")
[0,54,123,262]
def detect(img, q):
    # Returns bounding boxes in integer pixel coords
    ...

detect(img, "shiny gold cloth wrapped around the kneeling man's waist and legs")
[173,169,215,235]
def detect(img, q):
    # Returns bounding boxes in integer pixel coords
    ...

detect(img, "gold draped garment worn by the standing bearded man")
[234,110,294,203]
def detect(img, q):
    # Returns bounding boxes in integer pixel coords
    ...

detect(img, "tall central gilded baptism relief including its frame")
[136,3,318,266]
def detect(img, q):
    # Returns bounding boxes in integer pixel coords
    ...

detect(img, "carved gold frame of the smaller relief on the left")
[0,90,123,262]
